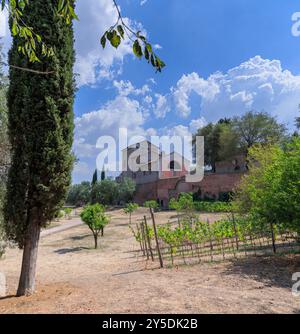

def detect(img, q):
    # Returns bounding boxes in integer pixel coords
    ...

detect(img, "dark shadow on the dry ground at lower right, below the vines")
[224,254,300,289]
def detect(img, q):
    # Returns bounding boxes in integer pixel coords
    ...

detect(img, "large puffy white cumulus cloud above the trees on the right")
[172,56,300,124]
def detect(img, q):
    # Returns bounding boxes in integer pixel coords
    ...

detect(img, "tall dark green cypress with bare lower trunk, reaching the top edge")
[5,0,75,296]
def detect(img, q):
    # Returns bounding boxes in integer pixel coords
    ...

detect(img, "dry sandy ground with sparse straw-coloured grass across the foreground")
[0,211,300,313]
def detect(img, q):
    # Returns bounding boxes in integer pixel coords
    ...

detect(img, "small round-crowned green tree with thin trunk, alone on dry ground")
[80,204,109,249]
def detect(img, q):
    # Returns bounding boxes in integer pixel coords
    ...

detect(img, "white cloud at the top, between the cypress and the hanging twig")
[75,0,143,86]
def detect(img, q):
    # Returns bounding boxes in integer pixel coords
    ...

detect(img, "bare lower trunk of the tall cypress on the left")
[17,220,41,297]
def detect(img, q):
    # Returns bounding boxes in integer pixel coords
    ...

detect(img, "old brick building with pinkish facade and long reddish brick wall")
[117,141,247,207]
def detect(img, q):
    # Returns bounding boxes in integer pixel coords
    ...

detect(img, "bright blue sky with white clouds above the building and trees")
[0,0,300,182]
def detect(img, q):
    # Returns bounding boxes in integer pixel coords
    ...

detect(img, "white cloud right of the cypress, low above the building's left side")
[73,95,157,182]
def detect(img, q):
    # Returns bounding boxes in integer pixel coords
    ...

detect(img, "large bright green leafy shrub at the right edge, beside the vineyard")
[234,137,300,234]
